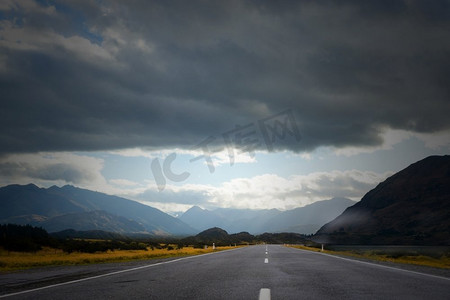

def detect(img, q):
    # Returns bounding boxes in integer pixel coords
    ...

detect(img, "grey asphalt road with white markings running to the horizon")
[0,245,450,300]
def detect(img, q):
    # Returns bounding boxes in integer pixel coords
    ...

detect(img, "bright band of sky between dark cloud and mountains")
[1,132,450,214]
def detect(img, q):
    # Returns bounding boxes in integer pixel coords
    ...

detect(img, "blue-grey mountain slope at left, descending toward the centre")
[0,184,197,235]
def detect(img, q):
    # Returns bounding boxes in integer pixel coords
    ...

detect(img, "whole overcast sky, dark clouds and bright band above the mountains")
[0,0,450,213]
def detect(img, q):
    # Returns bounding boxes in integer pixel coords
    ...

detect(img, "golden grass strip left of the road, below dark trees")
[0,247,234,272]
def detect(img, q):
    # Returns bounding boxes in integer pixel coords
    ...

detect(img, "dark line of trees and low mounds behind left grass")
[0,224,316,253]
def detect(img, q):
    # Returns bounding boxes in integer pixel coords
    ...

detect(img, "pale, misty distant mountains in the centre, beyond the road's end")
[179,198,355,234]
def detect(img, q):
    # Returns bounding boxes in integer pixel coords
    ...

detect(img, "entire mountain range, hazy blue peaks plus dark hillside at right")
[0,155,450,245]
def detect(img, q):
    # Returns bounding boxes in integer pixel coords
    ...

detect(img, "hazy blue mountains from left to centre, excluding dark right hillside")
[0,184,354,236]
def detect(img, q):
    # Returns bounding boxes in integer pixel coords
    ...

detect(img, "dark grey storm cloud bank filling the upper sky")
[0,1,450,153]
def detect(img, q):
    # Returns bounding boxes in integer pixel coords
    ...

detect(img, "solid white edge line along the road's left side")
[0,248,245,298]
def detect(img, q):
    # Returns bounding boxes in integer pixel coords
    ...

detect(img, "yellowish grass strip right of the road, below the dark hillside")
[288,245,450,269]
